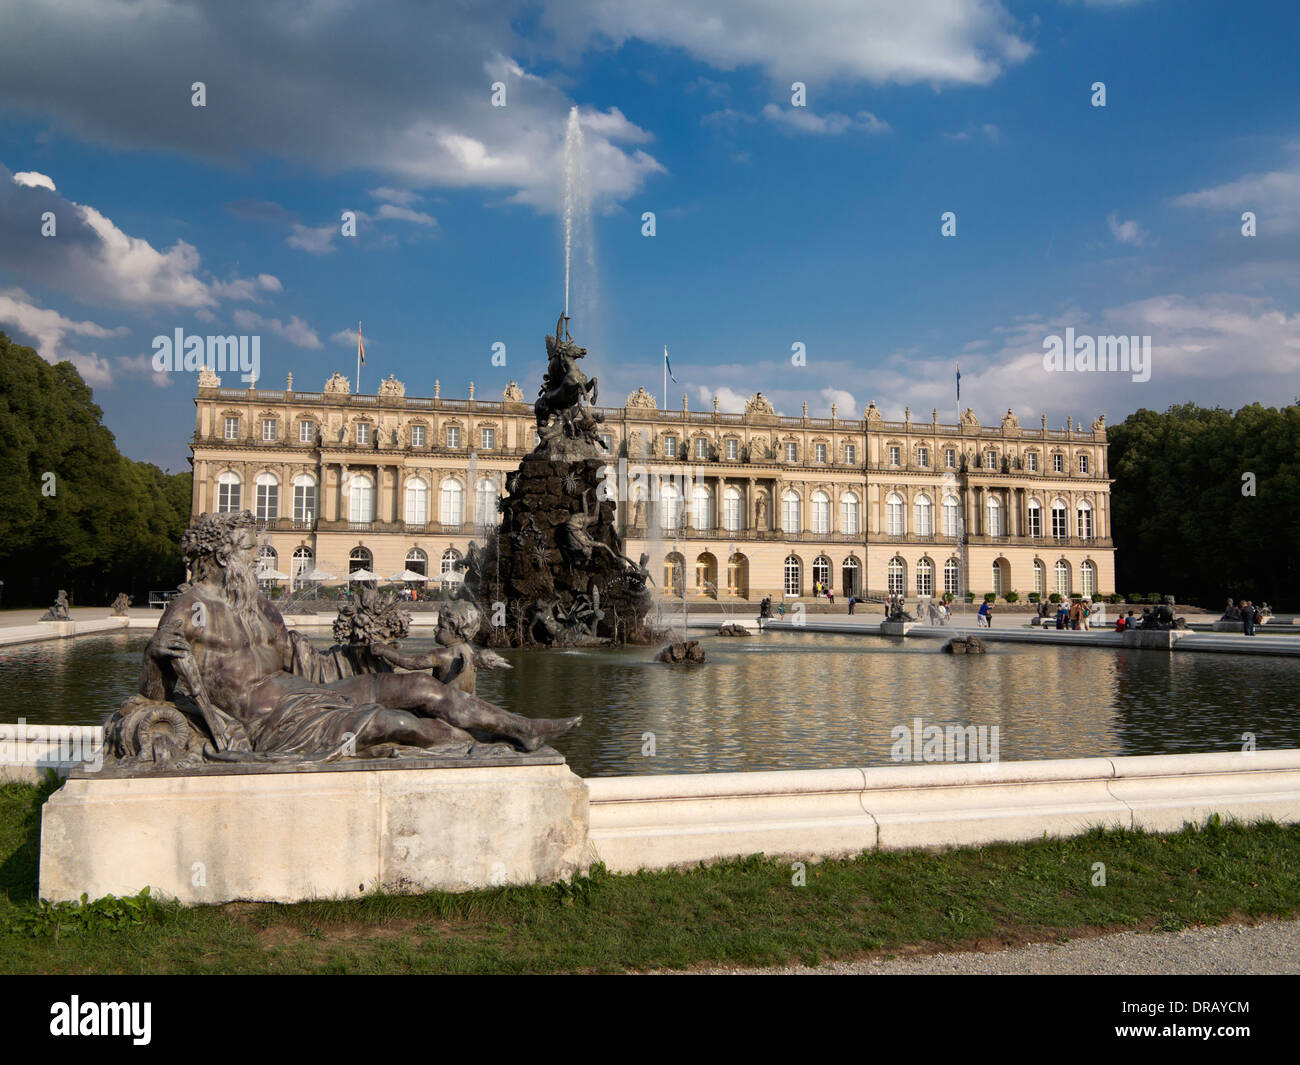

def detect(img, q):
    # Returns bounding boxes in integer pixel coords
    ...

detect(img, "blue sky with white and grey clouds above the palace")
[0,0,1300,471]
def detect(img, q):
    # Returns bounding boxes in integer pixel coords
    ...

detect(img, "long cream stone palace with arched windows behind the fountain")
[191,369,1115,603]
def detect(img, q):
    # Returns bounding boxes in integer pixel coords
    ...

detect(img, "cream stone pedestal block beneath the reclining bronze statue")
[40,756,588,904]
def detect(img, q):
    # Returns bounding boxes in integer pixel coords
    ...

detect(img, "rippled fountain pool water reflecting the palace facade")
[0,632,1300,776]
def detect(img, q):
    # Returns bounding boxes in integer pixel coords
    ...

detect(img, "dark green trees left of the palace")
[0,333,191,606]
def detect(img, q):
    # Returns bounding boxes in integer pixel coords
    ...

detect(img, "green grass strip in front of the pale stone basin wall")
[0,784,1300,973]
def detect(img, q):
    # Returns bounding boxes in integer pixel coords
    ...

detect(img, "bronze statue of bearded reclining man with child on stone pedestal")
[108,512,581,766]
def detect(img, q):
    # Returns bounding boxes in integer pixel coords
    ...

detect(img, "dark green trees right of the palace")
[1108,403,1300,611]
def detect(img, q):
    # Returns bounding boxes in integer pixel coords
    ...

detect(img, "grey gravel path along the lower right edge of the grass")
[670,921,1300,977]
